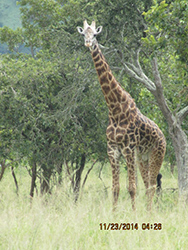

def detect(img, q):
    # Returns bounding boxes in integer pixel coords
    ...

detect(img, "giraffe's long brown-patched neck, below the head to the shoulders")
[91,44,131,113]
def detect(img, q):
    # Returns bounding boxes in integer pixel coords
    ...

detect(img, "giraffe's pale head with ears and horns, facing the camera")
[77,20,102,50]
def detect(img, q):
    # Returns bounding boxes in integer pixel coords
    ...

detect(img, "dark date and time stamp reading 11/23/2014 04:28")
[99,223,162,231]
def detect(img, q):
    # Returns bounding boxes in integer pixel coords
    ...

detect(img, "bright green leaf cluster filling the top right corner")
[144,0,188,64]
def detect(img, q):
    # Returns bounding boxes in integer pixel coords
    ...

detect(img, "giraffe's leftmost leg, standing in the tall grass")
[108,143,120,210]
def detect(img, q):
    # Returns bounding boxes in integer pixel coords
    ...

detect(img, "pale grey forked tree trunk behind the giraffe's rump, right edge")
[151,59,188,202]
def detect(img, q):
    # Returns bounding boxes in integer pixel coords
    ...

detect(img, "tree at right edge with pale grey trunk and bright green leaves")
[140,0,188,201]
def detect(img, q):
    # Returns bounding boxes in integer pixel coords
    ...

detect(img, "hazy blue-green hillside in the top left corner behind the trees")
[0,0,21,53]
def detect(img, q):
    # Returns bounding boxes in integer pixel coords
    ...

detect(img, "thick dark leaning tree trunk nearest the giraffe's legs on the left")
[74,154,86,202]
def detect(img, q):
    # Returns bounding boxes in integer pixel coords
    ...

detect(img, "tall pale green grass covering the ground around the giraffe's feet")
[0,165,188,250]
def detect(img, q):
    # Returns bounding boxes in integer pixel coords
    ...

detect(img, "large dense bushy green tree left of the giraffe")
[0,1,107,200]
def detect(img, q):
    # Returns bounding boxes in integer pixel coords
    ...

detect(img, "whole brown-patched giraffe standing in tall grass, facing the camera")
[77,20,166,210]
